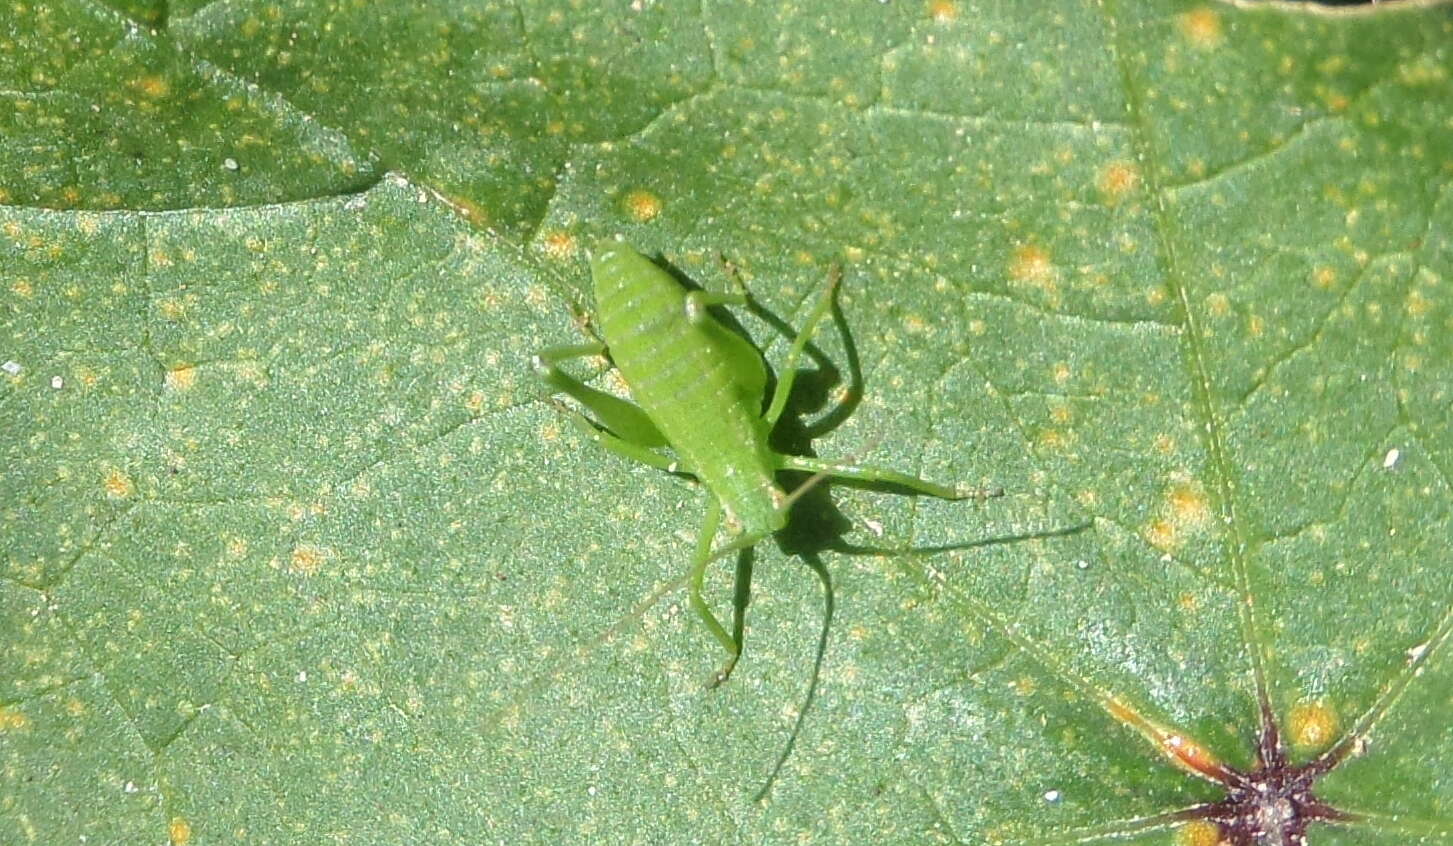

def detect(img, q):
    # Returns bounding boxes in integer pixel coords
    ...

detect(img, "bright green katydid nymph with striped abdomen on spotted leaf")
[532,240,984,685]
